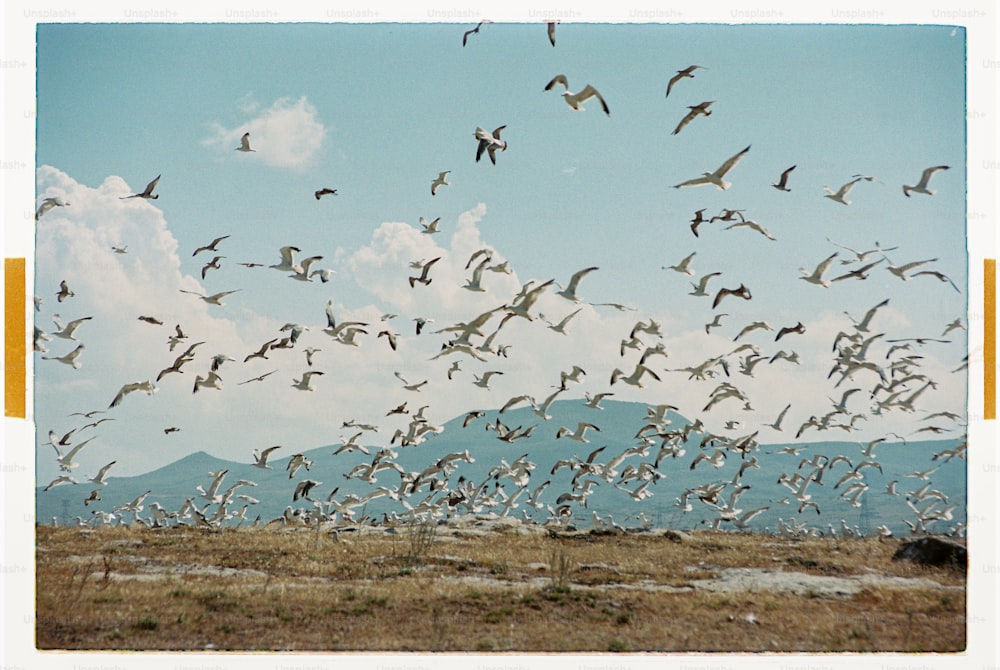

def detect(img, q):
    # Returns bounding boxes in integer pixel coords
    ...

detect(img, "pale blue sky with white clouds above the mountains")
[27,23,968,483]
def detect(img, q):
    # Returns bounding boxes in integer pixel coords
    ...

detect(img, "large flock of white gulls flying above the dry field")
[34,22,967,535]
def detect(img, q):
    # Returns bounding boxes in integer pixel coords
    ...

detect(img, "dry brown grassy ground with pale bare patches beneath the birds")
[36,527,966,652]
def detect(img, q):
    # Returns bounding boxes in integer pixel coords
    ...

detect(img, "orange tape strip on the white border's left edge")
[3,258,28,419]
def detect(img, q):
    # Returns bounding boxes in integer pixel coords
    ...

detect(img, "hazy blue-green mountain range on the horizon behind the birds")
[36,399,967,534]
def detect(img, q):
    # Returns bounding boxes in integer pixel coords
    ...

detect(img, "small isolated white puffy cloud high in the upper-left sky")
[202,96,327,170]
